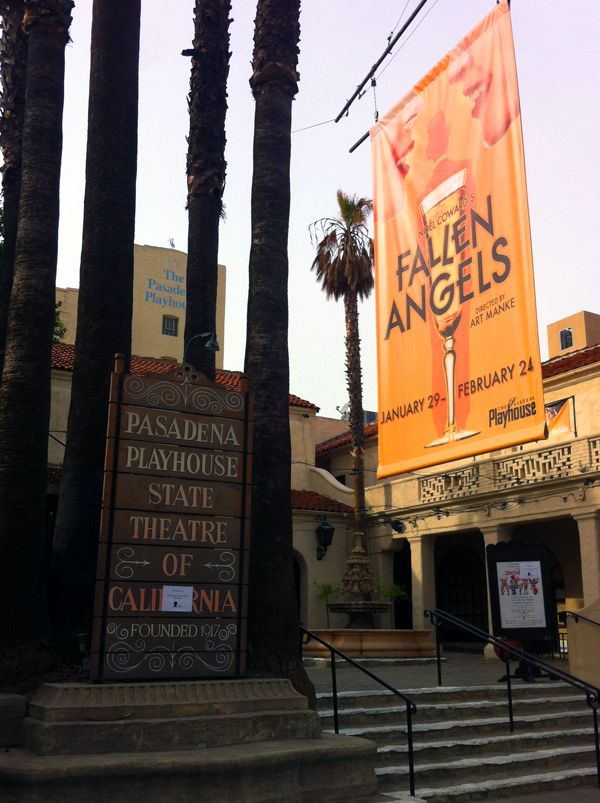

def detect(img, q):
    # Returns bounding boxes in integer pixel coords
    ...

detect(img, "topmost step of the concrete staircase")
[317,681,583,710]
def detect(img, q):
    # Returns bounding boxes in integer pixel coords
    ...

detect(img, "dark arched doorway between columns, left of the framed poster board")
[437,545,488,643]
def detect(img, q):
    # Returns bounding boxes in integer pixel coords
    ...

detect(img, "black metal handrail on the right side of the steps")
[425,608,600,786]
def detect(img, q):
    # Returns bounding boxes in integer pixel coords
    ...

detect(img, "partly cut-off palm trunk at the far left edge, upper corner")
[0,0,27,382]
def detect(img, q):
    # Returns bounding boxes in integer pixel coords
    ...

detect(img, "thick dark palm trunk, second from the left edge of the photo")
[0,0,73,682]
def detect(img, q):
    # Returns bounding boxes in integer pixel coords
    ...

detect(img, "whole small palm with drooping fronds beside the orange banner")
[310,190,374,595]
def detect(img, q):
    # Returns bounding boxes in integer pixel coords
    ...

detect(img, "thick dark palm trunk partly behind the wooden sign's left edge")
[52,0,140,638]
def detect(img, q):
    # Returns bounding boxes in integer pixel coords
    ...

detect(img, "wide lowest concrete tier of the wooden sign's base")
[0,735,377,803]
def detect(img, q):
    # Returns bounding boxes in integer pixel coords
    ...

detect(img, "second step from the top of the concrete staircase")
[318,694,587,727]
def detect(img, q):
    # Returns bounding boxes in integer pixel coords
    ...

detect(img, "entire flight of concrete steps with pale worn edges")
[318,680,600,803]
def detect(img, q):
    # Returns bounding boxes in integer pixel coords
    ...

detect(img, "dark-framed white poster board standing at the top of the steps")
[487,541,556,640]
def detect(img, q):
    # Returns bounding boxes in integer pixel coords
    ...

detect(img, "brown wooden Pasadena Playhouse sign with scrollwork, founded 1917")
[91,362,252,681]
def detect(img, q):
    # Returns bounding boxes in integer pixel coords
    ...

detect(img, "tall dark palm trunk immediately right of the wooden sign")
[245,0,314,700]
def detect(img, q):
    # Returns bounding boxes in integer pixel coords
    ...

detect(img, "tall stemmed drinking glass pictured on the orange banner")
[419,170,480,448]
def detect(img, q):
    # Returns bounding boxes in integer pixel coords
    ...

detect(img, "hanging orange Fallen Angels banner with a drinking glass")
[371,0,545,477]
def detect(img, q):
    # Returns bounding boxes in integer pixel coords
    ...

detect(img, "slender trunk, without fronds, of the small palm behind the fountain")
[344,290,367,551]
